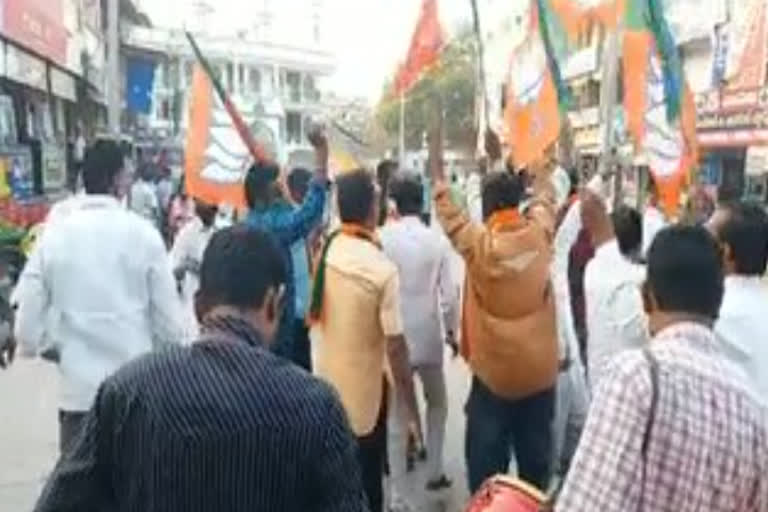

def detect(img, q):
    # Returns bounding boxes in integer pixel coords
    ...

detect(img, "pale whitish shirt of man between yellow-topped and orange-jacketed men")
[380,216,458,367]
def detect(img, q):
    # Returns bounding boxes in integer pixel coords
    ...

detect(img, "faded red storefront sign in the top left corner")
[0,0,69,66]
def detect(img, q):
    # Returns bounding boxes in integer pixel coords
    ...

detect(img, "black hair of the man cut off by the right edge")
[717,201,768,276]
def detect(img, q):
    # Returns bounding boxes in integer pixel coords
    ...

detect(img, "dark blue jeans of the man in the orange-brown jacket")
[464,377,555,493]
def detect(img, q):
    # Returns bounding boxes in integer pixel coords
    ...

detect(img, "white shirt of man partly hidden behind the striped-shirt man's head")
[171,217,215,341]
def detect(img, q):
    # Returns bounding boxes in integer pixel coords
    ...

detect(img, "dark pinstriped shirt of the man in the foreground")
[35,319,368,512]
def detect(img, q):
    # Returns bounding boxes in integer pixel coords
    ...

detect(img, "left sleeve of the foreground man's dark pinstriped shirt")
[34,382,116,512]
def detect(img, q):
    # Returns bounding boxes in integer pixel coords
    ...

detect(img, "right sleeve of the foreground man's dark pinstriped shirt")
[307,390,368,512]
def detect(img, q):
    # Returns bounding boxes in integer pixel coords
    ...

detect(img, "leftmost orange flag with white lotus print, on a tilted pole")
[184,65,277,209]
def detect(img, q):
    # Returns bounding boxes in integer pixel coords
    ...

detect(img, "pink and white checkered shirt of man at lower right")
[556,323,768,512]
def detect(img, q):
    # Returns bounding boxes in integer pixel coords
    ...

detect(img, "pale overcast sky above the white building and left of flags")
[141,0,471,101]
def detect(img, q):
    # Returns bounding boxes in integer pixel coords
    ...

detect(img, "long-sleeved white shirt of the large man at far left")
[15,196,182,412]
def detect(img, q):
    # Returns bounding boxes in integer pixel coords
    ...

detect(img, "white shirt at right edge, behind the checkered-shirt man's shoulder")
[715,276,768,405]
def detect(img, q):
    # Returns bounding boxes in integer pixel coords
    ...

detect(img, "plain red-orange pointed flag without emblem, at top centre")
[395,0,445,95]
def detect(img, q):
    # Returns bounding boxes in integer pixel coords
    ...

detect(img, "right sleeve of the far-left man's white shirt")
[147,232,184,348]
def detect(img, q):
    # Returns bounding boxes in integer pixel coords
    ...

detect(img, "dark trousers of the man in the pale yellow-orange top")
[357,382,387,512]
